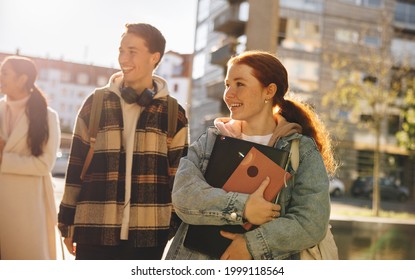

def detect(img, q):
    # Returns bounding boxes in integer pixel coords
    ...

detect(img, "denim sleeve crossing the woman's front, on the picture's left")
[172,127,248,225]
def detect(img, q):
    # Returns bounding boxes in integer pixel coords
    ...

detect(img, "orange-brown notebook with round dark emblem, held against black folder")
[223,147,291,230]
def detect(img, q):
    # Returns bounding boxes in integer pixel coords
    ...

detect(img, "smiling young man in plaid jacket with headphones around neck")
[58,23,188,260]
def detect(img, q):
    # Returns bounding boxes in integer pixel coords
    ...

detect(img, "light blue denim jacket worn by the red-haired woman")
[166,128,330,260]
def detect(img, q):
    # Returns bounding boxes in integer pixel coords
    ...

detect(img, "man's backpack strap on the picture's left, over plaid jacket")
[81,88,105,180]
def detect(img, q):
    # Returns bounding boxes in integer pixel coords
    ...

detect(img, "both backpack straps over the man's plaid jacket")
[81,88,179,180]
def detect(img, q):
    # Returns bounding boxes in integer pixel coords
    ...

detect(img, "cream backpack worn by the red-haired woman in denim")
[290,139,339,260]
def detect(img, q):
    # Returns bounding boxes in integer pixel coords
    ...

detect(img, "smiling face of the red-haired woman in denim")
[223,64,274,125]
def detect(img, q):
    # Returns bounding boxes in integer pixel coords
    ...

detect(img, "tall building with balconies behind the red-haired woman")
[190,0,415,197]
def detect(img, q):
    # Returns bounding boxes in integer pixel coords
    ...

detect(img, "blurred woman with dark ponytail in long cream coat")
[0,56,60,260]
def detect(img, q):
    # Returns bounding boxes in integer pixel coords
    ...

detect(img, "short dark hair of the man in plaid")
[123,23,166,67]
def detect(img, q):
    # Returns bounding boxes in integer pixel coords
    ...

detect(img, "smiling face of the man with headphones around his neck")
[118,33,160,90]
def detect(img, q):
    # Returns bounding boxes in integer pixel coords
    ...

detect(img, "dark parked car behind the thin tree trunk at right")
[351,176,409,202]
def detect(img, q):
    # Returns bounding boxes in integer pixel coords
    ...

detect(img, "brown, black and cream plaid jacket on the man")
[58,88,188,247]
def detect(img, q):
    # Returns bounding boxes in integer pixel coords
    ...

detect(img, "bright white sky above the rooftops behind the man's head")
[0,0,197,68]
